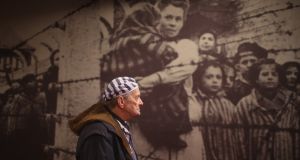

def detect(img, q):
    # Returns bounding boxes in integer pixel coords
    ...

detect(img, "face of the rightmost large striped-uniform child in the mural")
[256,64,279,89]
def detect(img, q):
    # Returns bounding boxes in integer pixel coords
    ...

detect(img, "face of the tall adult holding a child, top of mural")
[159,5,184,38]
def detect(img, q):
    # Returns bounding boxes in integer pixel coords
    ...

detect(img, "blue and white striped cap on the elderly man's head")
[102,77,139,101]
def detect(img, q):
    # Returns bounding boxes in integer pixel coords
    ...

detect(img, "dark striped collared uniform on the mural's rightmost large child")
[235,89,299,160]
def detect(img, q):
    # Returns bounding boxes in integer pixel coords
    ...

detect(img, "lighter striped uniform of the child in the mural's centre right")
[196,89,237,160]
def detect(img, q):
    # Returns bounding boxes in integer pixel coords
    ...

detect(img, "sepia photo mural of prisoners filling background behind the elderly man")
[0,0,300,160]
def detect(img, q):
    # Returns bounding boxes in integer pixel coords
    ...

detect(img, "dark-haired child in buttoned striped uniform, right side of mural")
[235,59,300,160]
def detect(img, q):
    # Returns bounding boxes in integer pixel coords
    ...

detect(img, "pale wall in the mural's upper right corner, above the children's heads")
[220,0,299,63]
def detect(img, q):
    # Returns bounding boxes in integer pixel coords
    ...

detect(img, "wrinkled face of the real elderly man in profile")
[124,89,143,119]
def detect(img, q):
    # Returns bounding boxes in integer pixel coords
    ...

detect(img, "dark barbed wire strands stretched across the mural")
[1,0,300,160]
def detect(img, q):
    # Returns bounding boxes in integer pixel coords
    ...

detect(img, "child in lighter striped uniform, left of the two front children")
[189,61,236,160]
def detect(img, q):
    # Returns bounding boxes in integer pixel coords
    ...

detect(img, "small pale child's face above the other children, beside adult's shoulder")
[198,33,216,51]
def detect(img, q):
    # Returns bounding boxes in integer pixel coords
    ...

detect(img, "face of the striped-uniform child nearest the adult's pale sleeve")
[202,66,223,94]
